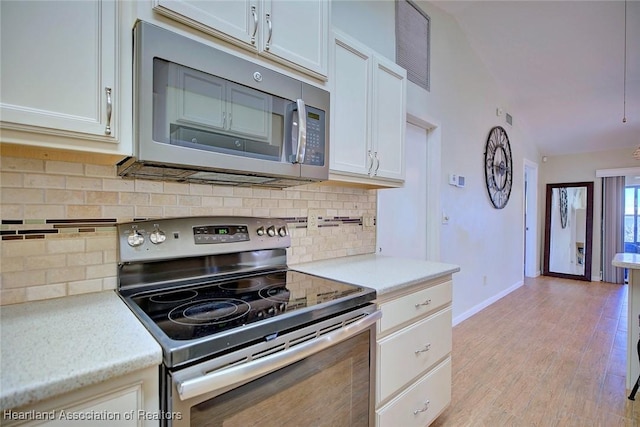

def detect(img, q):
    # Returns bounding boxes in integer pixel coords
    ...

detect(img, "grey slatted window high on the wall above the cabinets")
[396,0,431,90]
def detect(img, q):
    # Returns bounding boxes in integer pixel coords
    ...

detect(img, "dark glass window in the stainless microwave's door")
[153,58,284,162]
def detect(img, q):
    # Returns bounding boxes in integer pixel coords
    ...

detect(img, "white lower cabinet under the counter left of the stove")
[1,367,161,427]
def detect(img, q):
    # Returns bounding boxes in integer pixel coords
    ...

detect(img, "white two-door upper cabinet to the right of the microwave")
[329,31,406,187]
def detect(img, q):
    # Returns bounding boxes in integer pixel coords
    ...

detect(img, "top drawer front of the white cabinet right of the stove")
[378,281,452,333]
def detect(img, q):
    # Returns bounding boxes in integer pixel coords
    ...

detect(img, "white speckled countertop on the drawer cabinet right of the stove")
[289,254,460,296]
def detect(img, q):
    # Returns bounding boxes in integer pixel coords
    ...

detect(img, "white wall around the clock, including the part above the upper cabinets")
[332,1,539,323]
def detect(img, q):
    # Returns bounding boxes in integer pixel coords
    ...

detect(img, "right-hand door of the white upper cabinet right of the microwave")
[372,56,407,180]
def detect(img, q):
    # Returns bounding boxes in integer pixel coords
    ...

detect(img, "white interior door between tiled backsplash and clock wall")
[376,123,428,260]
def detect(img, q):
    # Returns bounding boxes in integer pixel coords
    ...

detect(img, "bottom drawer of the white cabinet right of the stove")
[376,358,451,427]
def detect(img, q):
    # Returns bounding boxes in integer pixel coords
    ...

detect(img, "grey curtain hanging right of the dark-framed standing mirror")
[602,176,624,283]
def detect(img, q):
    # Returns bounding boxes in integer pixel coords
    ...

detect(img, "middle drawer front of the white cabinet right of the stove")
[376,307,451,403]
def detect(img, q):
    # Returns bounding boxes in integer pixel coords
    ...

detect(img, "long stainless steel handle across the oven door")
[174,310,382,401]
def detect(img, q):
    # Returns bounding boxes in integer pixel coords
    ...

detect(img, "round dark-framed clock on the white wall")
[484,126,513,209]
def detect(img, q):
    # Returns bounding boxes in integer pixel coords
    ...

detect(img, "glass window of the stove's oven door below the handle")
[190,330,372,427]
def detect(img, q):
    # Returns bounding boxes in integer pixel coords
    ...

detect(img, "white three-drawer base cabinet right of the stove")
[376,275,453,427]
